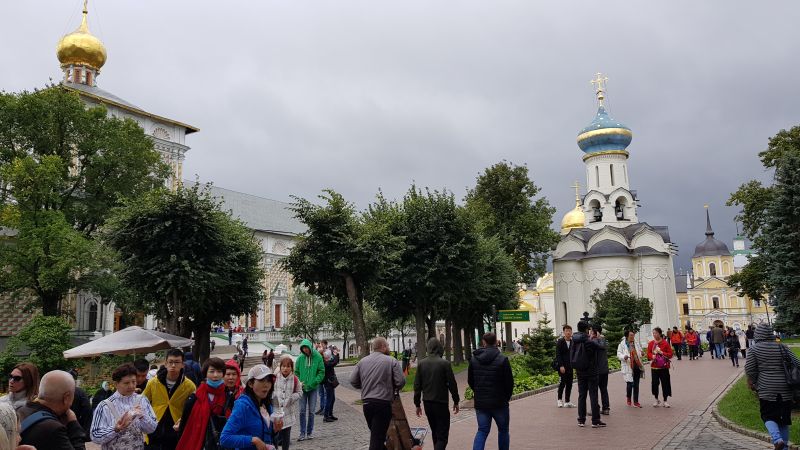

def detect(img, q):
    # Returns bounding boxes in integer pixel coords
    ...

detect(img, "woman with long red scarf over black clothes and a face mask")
[176,358,228,450]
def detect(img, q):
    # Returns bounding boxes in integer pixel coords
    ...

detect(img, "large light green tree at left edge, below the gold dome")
[0,86,169,316]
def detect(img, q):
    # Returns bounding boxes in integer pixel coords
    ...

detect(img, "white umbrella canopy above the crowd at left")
[64,326,194,359]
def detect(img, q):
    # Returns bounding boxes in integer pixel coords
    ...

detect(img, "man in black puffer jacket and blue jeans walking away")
[467,333,514,450]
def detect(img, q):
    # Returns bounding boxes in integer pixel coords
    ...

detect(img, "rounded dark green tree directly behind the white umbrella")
[106,185,264,361]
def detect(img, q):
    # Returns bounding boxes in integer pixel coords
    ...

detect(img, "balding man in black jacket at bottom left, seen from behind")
[17,370,86,450]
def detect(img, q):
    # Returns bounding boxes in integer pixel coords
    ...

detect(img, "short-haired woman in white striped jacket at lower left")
[91,363,158,450]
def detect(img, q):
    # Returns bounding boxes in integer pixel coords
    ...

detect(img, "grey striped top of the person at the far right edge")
[744,340,800,402]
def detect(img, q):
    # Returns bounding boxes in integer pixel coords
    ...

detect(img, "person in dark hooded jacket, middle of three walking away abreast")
[414,337,459,450]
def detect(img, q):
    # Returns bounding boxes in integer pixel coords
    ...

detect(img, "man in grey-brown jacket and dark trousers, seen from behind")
[350,337,406,450]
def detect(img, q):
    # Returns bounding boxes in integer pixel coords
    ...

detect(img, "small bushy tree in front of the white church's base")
[591,280,653,342]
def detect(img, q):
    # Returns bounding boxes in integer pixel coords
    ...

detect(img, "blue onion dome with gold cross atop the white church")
[578,74,633,155]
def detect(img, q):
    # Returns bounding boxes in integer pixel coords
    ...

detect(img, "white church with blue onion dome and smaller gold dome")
[553,73,678,333]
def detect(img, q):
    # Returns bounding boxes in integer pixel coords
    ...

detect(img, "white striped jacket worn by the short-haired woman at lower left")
[90,392,158,450]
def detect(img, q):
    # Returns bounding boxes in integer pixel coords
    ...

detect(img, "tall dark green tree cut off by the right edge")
[728,126,800,332]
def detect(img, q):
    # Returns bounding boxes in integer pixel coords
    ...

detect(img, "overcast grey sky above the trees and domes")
[0,0,800,269]
